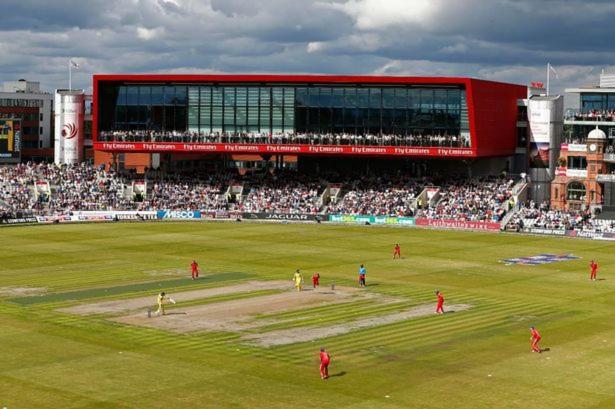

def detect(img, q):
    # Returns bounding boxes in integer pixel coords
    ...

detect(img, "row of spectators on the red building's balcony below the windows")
[99,131,470,148]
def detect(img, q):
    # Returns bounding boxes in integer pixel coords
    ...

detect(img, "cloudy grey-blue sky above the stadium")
[0,0,615,106]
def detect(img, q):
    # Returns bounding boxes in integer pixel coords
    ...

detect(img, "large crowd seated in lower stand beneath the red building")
[0,163,513,221]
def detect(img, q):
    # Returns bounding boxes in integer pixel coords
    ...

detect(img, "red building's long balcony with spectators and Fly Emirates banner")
[94,131,477,158]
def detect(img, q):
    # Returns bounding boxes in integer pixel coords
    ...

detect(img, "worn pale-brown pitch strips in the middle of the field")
[60,281,471,347]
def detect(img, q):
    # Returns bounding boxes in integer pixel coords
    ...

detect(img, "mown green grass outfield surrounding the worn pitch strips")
[0,222,615,409]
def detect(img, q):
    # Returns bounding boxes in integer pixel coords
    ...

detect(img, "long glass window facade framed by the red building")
[98,84,466,139]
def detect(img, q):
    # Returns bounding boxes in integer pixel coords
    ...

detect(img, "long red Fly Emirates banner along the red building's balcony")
[94,142,477,158]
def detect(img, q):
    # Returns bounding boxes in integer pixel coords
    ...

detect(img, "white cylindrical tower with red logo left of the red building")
[54,90,85,165]
